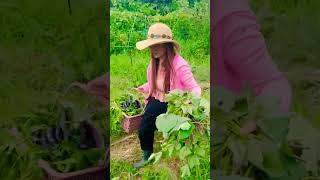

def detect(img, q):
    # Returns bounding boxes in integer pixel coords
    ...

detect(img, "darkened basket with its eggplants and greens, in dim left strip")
[32,105,108,180]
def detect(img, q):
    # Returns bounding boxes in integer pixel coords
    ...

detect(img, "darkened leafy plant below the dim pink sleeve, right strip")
[211,87,319,179]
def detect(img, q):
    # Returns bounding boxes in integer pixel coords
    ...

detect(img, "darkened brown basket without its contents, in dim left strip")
[38,121,109,180]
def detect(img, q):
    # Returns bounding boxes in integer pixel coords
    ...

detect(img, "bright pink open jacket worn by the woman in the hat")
[139,54,201,102]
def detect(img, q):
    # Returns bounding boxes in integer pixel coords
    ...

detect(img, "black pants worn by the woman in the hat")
[139,97,167,152]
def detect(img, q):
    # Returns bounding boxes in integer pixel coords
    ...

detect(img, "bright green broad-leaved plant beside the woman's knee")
[149,90,210,177]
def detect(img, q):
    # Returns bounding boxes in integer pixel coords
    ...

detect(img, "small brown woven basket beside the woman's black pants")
[121,112,143,133]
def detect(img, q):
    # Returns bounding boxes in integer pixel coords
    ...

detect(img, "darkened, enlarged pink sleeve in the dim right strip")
[210,0,291,111]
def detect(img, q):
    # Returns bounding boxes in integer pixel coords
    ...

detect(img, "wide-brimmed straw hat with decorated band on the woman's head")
[136,23,180,51]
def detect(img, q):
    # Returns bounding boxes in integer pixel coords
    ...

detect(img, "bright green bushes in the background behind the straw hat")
[110,1,210,59]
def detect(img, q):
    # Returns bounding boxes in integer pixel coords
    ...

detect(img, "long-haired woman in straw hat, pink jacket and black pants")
[134,23,201,167]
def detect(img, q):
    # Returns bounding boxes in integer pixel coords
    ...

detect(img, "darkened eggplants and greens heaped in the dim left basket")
[27,103,105,172]
